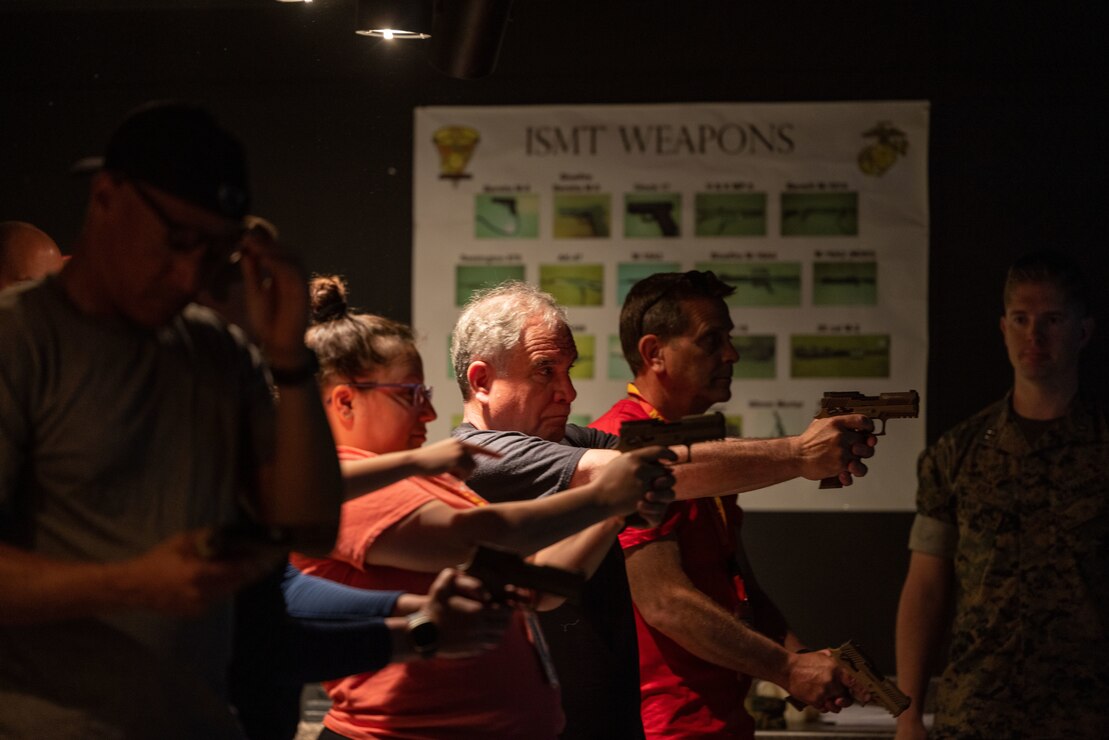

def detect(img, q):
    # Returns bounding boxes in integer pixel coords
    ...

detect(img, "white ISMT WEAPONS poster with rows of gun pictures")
[413,101,928,510]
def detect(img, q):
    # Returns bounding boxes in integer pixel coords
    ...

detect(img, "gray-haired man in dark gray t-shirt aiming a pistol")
[451,282,874,739]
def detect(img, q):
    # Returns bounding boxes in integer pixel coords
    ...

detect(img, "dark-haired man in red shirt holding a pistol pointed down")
[590,271,851,740]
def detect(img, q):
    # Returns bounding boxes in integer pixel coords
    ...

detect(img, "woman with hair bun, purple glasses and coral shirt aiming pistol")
[293,276,673,740]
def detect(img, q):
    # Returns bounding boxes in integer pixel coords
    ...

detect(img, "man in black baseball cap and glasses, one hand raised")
[0,103,340,738]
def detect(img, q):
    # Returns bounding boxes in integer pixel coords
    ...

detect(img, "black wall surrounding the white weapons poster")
[0,0,1109,671]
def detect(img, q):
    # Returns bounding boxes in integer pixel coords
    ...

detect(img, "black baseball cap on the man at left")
[73,101,251,221]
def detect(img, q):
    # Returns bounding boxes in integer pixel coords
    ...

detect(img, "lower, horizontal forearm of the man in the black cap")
[0,545,142,625]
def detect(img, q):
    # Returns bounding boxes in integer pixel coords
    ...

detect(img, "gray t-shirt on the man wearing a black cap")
[0,278,273,737]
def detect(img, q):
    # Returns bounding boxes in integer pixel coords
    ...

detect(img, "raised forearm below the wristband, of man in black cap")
[260,382,343,555]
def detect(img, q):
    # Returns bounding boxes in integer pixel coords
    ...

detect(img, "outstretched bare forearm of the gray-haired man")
[673,437,802,499]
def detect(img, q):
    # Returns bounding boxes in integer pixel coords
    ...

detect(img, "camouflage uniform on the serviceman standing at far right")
[909,394,1109,739]
